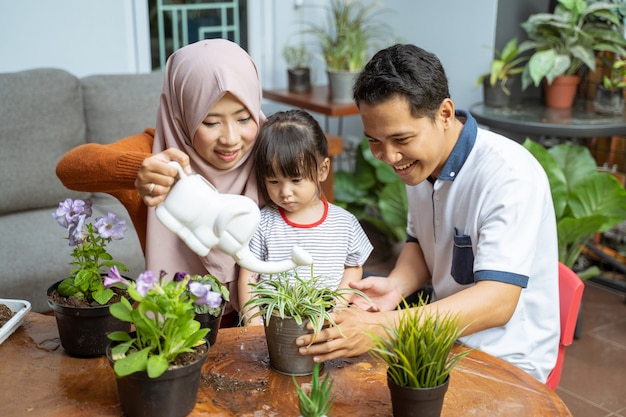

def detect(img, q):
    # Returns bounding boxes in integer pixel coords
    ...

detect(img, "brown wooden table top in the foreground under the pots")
[0,313,571,417]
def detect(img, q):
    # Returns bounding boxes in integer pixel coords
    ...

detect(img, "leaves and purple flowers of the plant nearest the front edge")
[104,267,222,378]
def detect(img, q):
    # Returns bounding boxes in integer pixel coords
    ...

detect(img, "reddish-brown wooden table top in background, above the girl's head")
[263,85,359,117]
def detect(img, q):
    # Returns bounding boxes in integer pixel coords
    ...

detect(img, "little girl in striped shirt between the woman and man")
[239,110,373,324]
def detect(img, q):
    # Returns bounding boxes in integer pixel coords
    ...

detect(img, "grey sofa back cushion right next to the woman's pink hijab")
[82,72,163,143]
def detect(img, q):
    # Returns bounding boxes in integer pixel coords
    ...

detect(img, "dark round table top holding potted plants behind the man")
[469,98,626,138]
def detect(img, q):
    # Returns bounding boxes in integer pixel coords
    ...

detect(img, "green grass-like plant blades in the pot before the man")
[370,297,472,388]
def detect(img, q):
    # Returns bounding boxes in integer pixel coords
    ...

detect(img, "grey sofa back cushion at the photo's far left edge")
[0,69,88,214]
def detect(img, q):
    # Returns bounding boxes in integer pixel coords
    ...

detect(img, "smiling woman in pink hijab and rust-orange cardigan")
[57,39,265,324]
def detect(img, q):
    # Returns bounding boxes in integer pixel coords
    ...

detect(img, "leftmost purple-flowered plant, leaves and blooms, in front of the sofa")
[52,198,128,305]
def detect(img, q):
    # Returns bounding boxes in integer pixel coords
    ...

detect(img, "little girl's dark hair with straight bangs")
[253,109,328,198]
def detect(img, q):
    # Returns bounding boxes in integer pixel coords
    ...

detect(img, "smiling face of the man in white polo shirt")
[359,96,462,185]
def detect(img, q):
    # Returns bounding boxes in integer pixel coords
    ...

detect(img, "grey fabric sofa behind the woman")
[0,69,163,312]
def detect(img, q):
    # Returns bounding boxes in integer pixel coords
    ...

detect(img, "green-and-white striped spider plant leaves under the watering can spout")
[242,266,367,340]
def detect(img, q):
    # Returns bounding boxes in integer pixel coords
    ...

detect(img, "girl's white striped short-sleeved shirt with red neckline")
[250,201,373,290]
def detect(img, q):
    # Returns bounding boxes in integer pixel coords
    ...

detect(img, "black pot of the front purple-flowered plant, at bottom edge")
[107,345,209,417]
